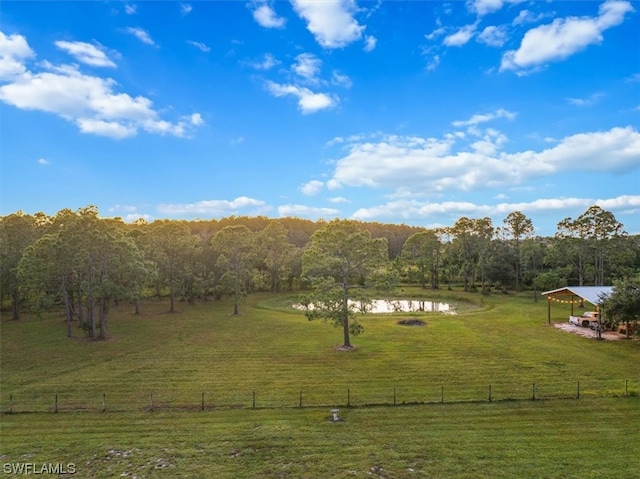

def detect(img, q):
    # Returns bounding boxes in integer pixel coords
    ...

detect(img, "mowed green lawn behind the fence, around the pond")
[0,289,640,411]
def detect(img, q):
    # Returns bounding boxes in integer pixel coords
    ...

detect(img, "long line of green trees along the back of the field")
[0,206,640,342]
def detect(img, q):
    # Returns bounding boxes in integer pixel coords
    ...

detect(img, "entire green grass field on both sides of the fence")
[0,289,640,478]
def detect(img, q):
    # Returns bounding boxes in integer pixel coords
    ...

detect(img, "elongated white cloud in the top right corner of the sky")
[500,0,633,73]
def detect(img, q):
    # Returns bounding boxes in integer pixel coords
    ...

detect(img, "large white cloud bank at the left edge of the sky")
[0,31,202,139]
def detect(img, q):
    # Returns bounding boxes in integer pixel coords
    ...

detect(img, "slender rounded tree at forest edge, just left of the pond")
[211,225,257,316]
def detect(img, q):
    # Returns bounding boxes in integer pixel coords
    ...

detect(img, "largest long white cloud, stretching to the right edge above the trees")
[327,127,640,192]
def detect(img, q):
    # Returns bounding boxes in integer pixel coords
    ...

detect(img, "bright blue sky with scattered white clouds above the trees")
[0,0,640,235]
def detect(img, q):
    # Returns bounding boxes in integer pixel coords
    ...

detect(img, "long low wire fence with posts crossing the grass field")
[0,379,640,414]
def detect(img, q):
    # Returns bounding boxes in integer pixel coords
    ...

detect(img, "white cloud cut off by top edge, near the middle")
[291,0,365,48]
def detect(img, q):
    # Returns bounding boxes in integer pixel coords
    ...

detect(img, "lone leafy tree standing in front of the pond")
[302,220,389,349]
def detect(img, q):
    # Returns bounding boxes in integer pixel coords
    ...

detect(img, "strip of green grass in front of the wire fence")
[0,397,640,479]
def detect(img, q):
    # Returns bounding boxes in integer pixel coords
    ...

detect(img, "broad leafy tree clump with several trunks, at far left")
[18,207,146,338]
